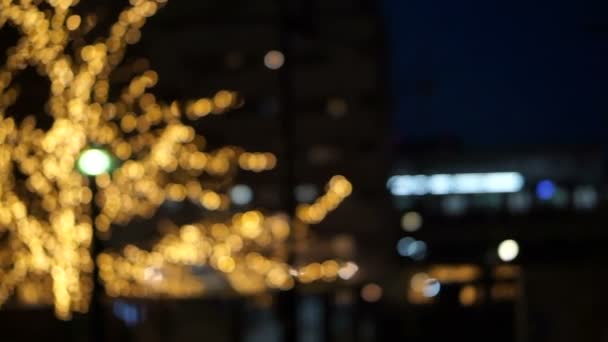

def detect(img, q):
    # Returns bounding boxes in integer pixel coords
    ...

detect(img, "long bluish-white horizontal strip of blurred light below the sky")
[387,172,524,196]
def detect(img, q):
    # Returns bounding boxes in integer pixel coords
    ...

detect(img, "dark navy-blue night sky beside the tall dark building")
[385,0,608,145]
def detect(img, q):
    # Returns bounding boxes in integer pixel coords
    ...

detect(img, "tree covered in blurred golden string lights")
[0,0,357,319]
